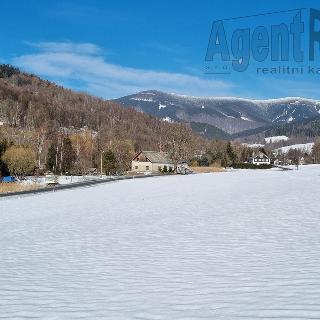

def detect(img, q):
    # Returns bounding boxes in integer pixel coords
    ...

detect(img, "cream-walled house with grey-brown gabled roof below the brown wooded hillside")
[131,151,174,173]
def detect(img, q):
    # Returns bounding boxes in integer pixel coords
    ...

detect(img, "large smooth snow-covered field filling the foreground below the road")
[0,166,320,320]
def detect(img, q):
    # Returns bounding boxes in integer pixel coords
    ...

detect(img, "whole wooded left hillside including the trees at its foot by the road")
[0,65,242,175]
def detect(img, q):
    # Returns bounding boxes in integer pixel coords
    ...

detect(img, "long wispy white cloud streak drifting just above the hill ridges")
[13,42,232,98]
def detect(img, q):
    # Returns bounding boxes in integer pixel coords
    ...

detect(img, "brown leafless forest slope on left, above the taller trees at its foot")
[0,66,191,149]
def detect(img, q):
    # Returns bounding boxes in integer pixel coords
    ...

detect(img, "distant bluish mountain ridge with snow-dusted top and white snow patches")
[116,90,320,134]
